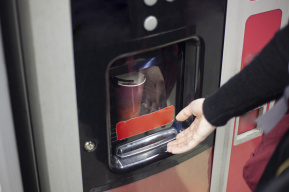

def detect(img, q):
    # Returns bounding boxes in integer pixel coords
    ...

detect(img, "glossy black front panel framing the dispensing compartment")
[71,0,226,192]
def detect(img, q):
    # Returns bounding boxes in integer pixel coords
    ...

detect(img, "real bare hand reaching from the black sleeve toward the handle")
[167,98,216,154]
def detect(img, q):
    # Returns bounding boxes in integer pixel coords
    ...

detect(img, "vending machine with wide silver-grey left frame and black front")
[1,0,227,192]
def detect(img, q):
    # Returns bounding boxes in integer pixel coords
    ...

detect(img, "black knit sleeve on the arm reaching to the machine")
[203,25,289,126]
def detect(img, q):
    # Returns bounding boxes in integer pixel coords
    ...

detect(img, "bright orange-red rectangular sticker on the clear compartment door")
[116,105,175,140]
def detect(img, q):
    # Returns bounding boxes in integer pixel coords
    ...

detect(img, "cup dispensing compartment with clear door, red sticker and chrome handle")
[107,37,201,171]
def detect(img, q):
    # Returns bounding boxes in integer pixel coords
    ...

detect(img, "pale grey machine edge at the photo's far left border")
[0,17,23,192]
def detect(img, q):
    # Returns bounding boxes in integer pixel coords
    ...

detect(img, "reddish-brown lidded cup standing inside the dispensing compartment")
[114,72,146,121]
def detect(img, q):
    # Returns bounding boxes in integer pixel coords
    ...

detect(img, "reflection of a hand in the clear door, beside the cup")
[141,66,167,114]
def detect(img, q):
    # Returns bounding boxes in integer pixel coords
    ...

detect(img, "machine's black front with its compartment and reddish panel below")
[71,0,226,192]
